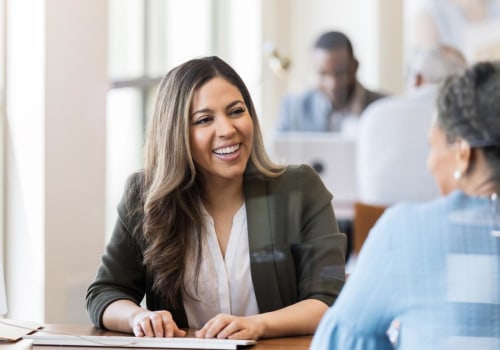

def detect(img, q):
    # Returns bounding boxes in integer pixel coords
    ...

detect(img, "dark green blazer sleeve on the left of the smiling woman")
[86,175,146,328]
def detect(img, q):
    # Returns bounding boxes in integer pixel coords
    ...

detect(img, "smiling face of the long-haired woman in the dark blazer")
[189,77,253,185]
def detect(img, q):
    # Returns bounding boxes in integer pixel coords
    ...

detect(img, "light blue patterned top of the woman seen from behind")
[311,191,500,350]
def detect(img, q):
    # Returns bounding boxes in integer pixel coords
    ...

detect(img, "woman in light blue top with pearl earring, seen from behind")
[311,62,500,350]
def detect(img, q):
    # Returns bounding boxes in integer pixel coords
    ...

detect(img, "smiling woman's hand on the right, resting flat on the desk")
[195,314,263,340]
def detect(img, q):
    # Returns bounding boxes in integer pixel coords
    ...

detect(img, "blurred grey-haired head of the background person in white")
[410,45,467,84]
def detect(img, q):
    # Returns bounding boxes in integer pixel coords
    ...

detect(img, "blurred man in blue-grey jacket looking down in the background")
[277,31,383,132]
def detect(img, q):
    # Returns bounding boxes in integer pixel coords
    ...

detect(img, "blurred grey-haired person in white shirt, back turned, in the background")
[357,46,466,206]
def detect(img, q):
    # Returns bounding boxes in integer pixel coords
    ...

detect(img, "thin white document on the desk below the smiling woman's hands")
[23,334,256,349]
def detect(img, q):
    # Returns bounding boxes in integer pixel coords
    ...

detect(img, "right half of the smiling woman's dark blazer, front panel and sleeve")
[245,165,346,312]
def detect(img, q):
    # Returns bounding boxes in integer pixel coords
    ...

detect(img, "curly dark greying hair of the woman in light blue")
[437,61,500,183]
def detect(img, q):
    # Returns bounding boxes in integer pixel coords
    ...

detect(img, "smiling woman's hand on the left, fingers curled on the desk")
[130,309,186,338]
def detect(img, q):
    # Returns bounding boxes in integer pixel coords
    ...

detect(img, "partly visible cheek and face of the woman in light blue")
[427,123,457,195]
